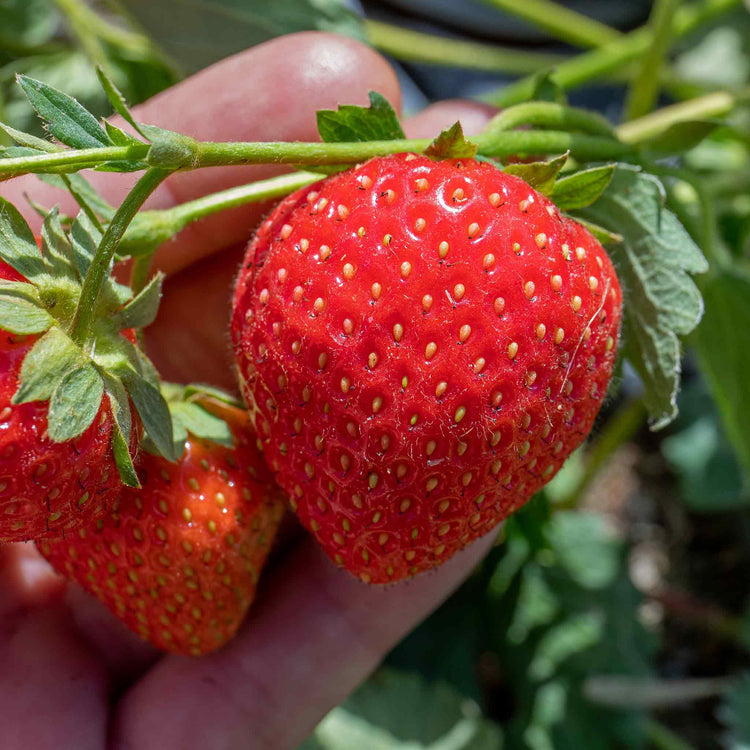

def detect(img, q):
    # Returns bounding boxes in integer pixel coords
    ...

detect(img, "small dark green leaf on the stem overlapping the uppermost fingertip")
[317,91,405,143]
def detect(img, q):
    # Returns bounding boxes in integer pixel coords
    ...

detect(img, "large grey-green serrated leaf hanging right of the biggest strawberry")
[583,164,708,429]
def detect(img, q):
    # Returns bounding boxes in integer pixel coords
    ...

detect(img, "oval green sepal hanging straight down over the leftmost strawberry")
[47,362,104,443]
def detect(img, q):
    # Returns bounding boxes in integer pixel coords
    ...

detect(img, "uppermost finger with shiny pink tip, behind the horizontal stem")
[3,32,400,271]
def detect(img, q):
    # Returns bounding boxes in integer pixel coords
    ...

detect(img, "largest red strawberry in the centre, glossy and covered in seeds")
[232,154,622,583]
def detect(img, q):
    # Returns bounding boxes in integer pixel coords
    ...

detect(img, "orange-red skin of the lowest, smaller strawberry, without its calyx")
[37,407,284,656]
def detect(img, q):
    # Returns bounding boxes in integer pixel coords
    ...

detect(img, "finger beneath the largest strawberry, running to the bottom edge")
[114,535,500,750]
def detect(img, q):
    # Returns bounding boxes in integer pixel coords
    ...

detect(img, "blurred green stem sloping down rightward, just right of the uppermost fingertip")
[365,19,565,75]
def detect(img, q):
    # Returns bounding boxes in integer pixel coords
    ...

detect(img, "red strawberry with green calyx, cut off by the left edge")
[0,207,172,543]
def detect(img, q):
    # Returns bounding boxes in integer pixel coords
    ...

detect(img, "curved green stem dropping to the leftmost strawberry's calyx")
[70,169,169,345]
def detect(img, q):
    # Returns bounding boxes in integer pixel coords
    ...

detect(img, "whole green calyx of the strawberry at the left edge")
[0,199,177,487]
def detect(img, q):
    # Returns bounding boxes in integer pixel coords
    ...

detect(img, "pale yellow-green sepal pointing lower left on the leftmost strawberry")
[13,326,81,404]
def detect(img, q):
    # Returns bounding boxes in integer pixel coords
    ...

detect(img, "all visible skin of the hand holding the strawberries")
[0,33,500,750]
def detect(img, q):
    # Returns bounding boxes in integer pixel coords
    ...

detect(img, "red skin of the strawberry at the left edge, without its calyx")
[0,261,135,543]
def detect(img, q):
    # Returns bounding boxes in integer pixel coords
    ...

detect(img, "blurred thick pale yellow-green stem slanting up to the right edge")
[616,89,750,145]
